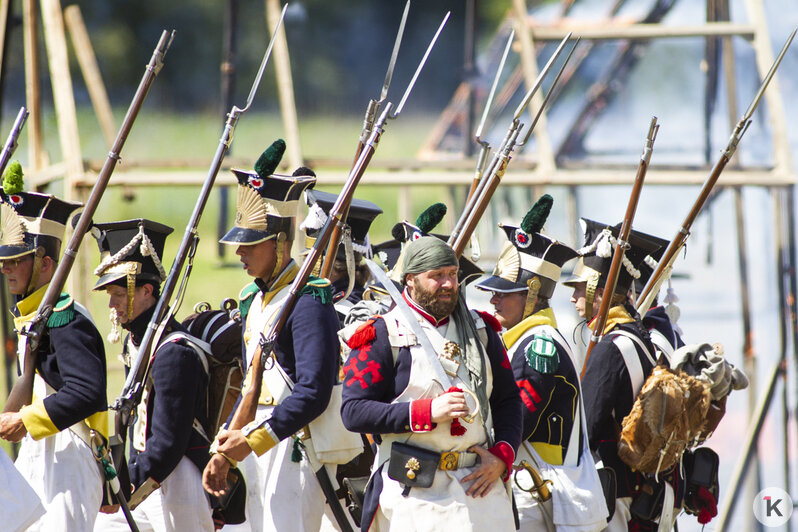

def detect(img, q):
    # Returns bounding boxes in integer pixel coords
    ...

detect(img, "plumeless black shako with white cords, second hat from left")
[91,218,173,290]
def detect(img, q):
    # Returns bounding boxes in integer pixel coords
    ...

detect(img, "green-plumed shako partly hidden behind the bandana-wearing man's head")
[374,203,484,284]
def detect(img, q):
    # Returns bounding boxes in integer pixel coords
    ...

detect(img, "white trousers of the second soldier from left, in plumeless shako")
[94,456,213,532]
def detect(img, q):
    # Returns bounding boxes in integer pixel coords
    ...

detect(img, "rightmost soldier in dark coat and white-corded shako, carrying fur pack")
[564,218,683,531]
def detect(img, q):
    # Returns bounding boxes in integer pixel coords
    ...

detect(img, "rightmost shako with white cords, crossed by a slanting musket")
[564,218,668,294]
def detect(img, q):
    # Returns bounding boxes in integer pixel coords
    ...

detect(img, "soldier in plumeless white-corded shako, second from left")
[92,219,213,532]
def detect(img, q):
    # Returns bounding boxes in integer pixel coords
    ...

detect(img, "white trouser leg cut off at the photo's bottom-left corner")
[0,451,44,532]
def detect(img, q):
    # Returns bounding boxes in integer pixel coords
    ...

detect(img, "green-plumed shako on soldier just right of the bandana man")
[476,194,577,298]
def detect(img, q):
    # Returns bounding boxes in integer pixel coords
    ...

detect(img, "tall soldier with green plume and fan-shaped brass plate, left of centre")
[203,140,339,532]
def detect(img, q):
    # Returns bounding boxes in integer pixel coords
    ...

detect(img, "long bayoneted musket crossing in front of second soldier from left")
[111,8,288,441]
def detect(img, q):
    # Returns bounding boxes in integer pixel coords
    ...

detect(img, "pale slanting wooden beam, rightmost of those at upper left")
[64,4,116,148]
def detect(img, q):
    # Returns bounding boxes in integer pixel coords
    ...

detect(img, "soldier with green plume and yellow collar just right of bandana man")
[476,194,607,532]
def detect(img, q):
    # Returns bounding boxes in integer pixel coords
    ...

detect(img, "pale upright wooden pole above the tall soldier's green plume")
[266,0,302,171]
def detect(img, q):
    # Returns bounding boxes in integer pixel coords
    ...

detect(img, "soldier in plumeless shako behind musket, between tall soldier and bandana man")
[300,190,382,325]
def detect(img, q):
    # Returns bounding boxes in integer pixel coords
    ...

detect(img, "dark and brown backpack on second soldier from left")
[183,299,244,441]
